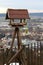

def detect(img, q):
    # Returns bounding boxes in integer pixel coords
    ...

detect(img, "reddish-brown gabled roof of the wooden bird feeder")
[6,9,29,19]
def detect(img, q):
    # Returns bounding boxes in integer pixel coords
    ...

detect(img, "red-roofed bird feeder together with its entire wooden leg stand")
[0,9,30,65]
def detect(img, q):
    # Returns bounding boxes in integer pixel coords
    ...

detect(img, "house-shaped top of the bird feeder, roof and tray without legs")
[6,9,30,26]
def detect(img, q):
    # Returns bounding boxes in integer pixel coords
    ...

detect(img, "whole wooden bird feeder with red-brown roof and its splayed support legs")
[6,9,30,65]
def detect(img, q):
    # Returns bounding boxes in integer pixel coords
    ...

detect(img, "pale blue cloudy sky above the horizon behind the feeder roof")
[0,0,43,13]
